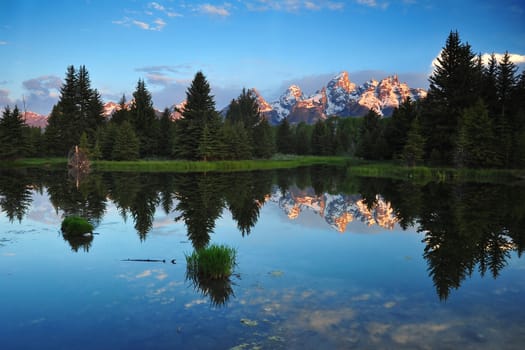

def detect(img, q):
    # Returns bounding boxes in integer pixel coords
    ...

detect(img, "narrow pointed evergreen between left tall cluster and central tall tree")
[129,79,158,157]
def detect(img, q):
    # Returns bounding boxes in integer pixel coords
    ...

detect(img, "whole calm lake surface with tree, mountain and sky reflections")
[0,166,525,350]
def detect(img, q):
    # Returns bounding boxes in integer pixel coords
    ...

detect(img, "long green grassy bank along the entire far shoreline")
[0,155,525,183]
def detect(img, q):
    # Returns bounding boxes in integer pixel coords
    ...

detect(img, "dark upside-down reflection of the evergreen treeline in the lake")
[0,166,525,305]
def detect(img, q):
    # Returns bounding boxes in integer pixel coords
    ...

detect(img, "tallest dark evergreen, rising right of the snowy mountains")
[421,31,481,163]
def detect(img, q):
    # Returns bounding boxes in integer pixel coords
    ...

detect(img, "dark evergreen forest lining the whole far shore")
[0,31,525,168]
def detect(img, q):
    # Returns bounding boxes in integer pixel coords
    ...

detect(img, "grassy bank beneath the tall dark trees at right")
[348,162,525,183]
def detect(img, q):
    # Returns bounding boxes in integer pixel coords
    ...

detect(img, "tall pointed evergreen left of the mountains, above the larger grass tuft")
[175,71,220,160]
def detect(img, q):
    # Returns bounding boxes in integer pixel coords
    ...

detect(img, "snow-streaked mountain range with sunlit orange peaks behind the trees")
[20,71,427,127]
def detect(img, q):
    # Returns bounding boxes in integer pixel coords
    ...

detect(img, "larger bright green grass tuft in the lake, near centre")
[186,244,237,280]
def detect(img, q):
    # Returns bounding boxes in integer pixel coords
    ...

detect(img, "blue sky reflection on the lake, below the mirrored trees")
[0,187,525,349]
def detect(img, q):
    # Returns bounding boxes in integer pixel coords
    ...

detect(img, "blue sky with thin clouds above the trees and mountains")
[0,0,525,114]
